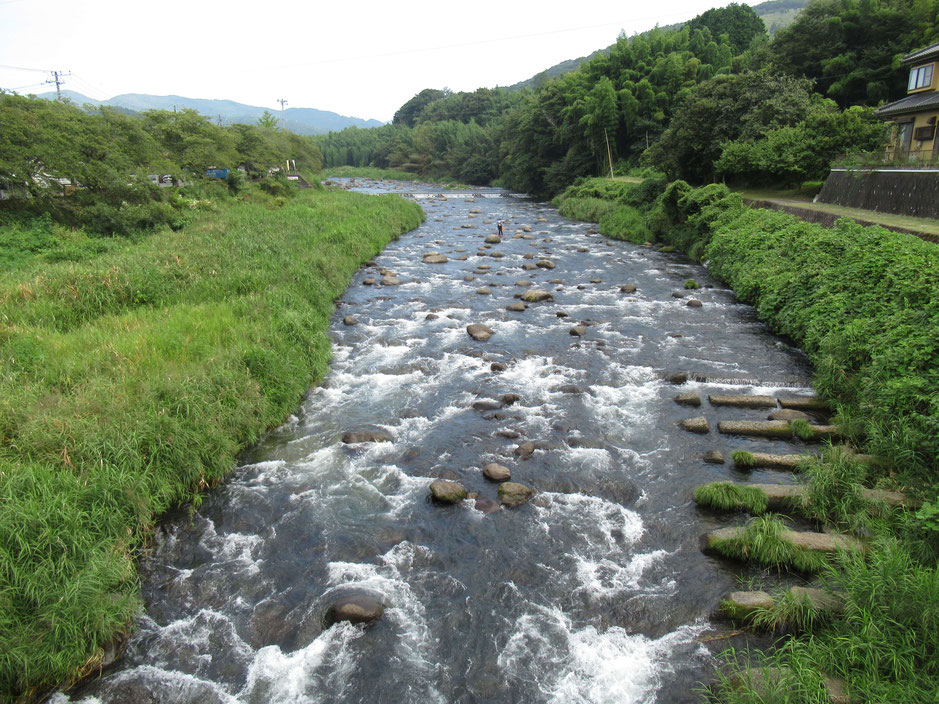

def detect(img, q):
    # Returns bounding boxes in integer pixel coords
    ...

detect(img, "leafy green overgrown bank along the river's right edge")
[557,178,939,702]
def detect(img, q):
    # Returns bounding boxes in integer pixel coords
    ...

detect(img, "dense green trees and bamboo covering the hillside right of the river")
[317,0,939,196]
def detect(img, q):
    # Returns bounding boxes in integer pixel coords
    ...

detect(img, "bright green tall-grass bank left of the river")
[0,186,423,701]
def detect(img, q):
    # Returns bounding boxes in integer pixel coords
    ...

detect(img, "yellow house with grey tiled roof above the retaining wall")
[874,42,939,161]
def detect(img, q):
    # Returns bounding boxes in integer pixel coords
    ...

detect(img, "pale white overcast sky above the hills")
[0,0,756,121]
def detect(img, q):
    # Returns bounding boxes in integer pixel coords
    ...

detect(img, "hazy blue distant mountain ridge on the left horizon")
[39,90,384,134]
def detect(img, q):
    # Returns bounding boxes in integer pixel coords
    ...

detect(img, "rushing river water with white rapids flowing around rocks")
[62,182,811,704]
